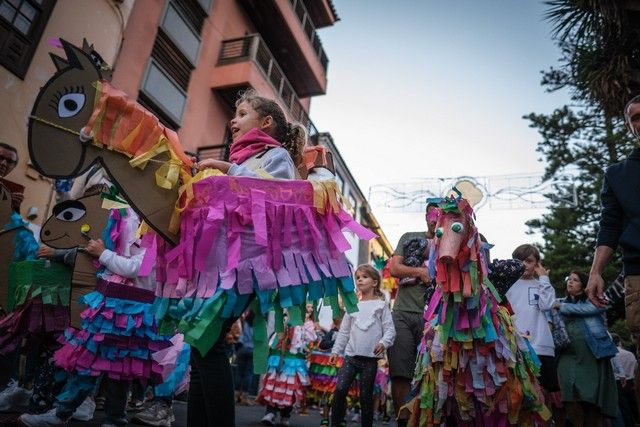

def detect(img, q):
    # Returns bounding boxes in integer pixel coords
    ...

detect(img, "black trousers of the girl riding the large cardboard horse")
[187,328,236,427]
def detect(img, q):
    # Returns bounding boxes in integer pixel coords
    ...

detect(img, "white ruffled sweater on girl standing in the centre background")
[331,300,396,357]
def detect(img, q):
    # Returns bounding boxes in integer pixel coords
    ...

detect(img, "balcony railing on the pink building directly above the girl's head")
[218,34,318,136]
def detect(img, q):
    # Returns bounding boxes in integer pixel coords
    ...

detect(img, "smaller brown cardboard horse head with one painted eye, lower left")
[40,191,109,327]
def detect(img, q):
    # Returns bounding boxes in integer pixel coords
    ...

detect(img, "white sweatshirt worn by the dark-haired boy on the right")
[507,276,556,356]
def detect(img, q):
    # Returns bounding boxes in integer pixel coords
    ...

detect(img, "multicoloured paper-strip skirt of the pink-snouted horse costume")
[404,286,551,427]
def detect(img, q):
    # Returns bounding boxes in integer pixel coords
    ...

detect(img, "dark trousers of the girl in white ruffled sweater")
[331,356,378,427]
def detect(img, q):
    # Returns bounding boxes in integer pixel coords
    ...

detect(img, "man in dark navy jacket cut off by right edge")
[587,96,640,334]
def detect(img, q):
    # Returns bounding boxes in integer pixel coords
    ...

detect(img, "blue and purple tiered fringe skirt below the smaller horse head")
[54,280,189,395]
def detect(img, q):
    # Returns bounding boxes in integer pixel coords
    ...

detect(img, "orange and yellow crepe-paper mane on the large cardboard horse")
[83,80,193,187]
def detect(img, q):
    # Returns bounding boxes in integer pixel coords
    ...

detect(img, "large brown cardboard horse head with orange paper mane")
[29,40,191,244]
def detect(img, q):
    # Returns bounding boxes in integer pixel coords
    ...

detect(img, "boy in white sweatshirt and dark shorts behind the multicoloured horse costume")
[506,244,560,416]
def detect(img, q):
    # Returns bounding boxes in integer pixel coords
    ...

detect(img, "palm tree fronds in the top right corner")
[545,0,640,118]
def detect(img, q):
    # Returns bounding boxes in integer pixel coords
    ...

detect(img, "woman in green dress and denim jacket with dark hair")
[553,271,618,426]
